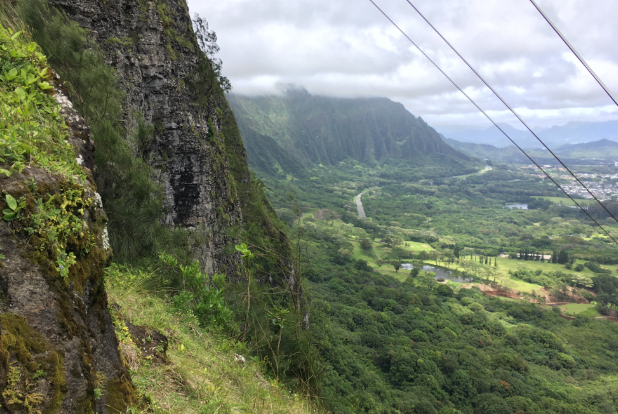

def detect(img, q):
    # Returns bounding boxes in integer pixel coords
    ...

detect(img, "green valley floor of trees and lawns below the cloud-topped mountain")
[253,151,618,413]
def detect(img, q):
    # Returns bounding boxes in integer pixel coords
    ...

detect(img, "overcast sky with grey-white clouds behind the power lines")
[188,0,618,131]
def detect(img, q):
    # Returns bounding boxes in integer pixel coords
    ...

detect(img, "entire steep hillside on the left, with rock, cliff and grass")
[0,0,315,413]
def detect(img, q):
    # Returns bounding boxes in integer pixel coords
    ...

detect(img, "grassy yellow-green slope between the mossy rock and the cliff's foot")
[106,266,315,414]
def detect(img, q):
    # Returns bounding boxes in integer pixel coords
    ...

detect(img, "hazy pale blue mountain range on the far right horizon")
[436,121,618,150]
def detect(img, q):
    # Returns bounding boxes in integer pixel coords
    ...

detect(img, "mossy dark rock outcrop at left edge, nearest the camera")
[0,51,137,413]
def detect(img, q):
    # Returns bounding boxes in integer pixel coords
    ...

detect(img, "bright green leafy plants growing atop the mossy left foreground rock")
[0,25,77,178]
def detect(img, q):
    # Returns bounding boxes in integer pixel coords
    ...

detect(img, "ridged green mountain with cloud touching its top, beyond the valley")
[229,89,468,175]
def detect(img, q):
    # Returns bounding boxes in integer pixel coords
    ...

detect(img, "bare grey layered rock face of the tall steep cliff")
[50,0,245,276]
